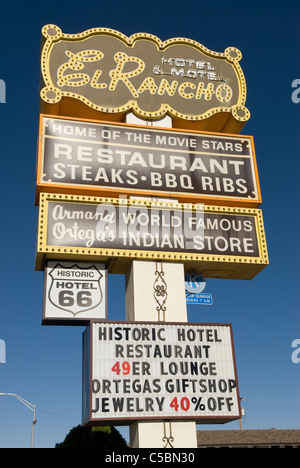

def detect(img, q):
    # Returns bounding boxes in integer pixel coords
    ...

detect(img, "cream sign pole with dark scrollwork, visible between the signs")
[126,114,197,448]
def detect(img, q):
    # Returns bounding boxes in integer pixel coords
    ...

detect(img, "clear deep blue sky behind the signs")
[0,0,300,448]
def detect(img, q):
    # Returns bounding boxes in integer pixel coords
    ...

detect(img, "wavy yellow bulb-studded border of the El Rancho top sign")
[40,24,250,131]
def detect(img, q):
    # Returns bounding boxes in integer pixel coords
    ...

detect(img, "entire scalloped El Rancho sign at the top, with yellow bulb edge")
[41,24,250,133]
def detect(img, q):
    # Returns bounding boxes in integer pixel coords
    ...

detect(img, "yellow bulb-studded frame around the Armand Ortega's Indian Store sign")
[36,193,268,279]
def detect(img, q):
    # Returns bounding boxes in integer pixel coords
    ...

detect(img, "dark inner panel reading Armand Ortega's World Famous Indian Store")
[47,202,259,257]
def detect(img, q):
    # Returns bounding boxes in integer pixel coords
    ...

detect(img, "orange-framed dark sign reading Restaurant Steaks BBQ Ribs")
[37,116,260,206]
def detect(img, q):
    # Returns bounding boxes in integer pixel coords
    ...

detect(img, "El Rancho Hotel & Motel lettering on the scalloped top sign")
[57,50,233,103]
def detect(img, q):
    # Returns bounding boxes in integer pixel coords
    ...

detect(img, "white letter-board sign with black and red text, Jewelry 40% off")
[82,322,240,426]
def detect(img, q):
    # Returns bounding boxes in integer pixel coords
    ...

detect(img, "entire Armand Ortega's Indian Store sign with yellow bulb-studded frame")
[36,193,268,279]
